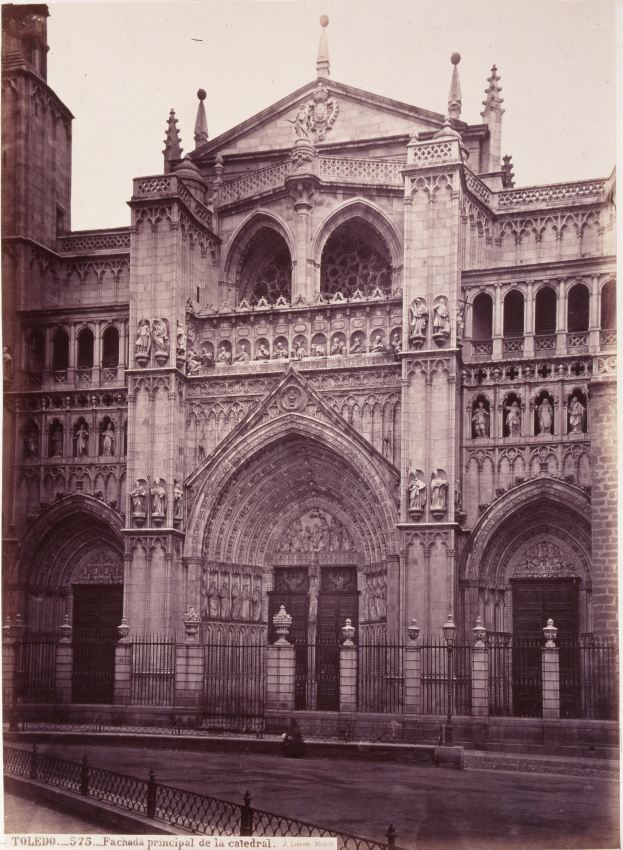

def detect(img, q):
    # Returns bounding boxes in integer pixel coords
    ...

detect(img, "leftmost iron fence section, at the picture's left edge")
[14,634,58,704]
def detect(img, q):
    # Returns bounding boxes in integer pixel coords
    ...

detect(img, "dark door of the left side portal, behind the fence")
[72,584,123,704]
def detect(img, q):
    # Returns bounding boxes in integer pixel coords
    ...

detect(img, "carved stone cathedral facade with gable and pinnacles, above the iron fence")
[2,6,617,724]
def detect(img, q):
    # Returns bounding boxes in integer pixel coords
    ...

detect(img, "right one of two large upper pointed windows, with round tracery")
[320,218,392,298]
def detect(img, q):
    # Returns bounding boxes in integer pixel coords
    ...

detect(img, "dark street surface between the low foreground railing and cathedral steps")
[6,743,619,850]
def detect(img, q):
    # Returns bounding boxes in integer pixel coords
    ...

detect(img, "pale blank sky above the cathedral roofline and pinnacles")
[48,0,615,230]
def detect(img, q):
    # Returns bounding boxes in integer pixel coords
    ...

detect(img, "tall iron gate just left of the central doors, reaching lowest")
[203,641,266,732]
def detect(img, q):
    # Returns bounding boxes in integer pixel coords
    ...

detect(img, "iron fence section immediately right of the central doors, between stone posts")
[357,643,405,714]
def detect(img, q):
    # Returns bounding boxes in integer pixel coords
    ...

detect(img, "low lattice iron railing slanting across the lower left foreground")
[3,745,398,850]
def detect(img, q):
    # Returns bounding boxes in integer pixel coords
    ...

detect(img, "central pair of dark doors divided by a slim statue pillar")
[269,564,359,711]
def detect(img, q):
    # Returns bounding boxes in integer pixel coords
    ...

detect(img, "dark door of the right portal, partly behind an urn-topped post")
[511,579,579,717]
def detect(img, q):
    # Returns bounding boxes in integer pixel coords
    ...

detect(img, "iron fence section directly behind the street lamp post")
[421,638,472,715]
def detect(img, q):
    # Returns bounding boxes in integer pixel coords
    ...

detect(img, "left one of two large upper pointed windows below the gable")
[237,227,292,307]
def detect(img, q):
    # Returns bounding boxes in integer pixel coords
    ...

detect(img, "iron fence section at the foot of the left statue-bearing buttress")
[130,637,175,705]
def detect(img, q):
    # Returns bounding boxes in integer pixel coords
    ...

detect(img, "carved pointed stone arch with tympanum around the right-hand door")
[460,477,592,631]
